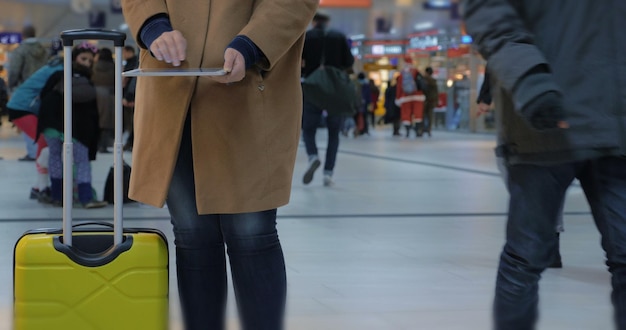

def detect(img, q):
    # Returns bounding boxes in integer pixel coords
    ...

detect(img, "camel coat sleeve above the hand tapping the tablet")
[122,0,169,48]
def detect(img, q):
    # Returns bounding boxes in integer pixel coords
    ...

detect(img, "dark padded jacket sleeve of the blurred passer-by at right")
[464,0,560,110]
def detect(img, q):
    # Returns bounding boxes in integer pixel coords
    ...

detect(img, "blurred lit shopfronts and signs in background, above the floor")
[0,0,494,132]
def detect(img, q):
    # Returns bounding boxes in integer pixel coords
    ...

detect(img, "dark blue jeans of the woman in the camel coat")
[167,114,287,330]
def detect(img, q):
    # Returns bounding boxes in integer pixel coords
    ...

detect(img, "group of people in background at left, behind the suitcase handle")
[0,26,137,209]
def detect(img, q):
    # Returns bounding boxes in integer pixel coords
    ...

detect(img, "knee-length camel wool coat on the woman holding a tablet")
[122,0,319,214]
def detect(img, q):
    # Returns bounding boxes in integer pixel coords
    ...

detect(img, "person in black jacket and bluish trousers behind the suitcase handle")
[37,43,107,208]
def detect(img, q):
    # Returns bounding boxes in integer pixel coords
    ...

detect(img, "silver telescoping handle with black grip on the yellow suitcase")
[61,29,126,246]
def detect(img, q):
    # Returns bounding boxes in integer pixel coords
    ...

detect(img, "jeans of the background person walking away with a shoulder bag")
[302,101,343,172]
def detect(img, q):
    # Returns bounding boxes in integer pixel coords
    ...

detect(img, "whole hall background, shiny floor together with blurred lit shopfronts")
[0,0,612,330]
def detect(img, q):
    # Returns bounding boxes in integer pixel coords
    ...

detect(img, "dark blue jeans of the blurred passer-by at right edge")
[494,157,626,330]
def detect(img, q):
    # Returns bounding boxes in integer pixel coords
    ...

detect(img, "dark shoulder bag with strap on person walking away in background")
[302,32,357,115]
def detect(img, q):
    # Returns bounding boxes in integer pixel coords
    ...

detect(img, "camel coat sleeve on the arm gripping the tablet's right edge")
[238,0,319,70]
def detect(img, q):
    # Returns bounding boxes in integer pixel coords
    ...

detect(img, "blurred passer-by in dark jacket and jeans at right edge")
[464,0,626,330]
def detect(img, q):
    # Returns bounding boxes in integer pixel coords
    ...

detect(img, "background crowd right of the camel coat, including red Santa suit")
[301,11,439,187]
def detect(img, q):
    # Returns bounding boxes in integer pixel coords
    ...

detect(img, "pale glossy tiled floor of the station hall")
[0,123,612,330]
